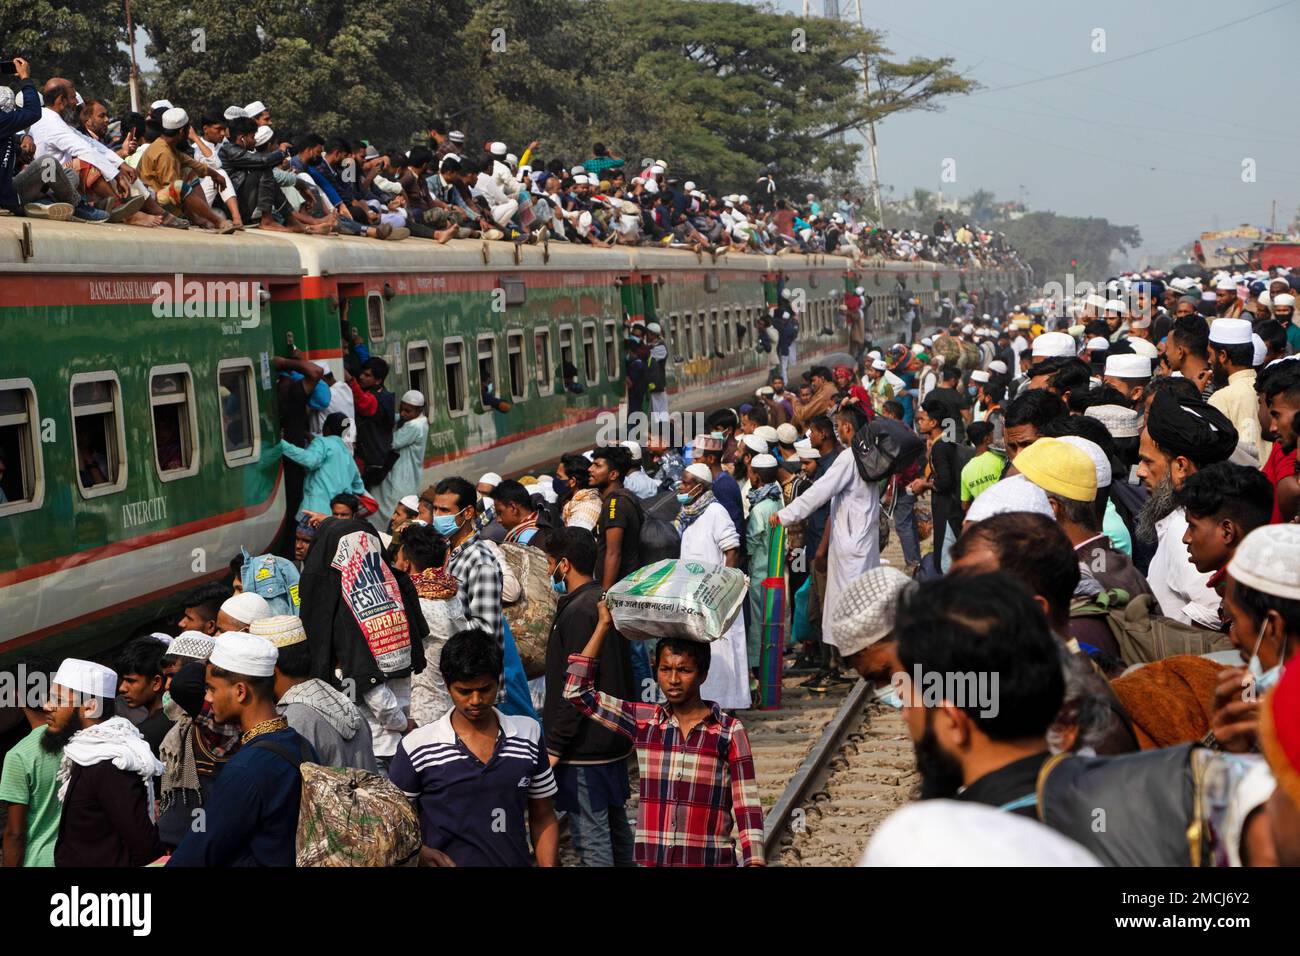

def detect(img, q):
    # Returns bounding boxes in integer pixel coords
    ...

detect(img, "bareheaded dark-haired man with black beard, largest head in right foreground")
[894,574,1065,818]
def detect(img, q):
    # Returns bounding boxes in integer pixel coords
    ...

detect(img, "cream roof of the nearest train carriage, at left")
[0,216,303,276]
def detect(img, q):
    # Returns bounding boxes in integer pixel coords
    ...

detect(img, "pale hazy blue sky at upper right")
[772,0,1300,265]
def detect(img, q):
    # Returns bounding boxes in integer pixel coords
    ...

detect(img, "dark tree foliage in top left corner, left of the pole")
[0,0,130,100]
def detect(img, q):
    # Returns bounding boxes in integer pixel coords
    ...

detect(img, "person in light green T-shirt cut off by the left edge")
[0,658,62,866]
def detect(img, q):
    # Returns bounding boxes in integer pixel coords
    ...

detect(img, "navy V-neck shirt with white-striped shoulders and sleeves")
[389,710,558,866]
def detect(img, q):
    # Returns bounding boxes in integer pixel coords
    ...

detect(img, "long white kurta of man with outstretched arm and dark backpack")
[776,449,880,644]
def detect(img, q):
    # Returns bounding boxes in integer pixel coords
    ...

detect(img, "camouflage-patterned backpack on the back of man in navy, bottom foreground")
[250,740,421,866]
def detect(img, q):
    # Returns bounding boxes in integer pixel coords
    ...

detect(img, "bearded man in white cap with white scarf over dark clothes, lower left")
[48,657,163,866]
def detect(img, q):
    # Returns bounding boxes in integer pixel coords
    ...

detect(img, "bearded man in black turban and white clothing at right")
[1138,390,1236,630]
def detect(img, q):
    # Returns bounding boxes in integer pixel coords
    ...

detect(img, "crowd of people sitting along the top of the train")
[0,59,1017,267]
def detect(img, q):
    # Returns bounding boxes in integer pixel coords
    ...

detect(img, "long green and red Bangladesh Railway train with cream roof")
[0,217,1022,661]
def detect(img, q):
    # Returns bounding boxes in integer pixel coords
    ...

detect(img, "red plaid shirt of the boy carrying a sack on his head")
[564,654,763,866]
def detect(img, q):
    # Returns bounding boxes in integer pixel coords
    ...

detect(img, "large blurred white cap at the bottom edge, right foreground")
[858,801,1101,866]
